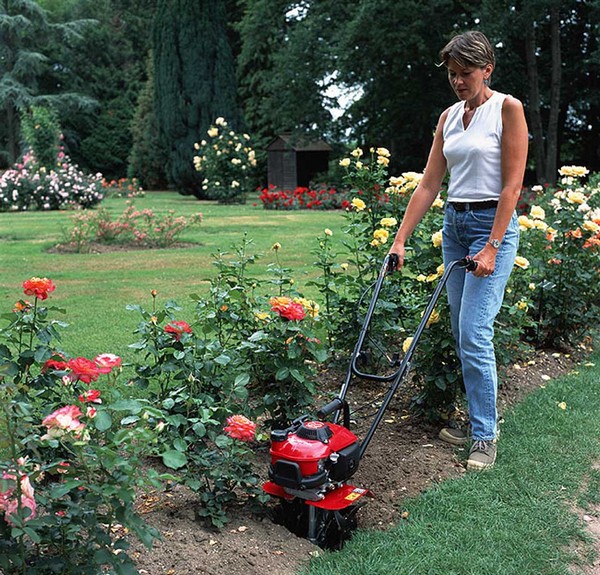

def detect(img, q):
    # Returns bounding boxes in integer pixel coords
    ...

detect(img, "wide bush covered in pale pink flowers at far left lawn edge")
[0,151,104,211]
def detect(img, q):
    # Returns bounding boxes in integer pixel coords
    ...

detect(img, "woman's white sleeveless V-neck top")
[443,92,506,202]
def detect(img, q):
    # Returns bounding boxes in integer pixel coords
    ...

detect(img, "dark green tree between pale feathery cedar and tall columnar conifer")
[46,0,156,178]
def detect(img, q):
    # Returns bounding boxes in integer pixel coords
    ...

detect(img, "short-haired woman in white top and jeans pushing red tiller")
[390,32,528,470]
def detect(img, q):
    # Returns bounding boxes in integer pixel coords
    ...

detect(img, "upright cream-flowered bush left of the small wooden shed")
[194,118,256,204]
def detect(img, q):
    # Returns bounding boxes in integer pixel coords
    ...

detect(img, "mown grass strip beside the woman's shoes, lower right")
[305,353,600,575]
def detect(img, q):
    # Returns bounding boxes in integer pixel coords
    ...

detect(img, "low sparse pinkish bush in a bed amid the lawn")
[65,201,202,252]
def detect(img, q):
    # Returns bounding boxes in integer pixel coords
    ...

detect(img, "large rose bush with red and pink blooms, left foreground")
[0,278,166,574]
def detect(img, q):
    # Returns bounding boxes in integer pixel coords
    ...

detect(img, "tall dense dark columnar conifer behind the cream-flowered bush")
[154,0,241,196]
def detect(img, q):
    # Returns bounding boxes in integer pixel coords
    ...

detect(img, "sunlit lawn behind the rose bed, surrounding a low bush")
[0,192,343,358]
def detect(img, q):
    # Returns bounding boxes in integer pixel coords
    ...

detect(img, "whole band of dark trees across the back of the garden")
[0,0,600,191]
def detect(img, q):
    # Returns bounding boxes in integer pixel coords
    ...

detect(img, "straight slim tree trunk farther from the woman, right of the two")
[544,6,562,183]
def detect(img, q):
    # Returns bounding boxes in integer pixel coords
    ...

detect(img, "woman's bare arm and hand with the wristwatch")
[473,96,529,276]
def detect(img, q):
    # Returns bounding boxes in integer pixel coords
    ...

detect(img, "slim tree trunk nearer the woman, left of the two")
[525,21,546,183]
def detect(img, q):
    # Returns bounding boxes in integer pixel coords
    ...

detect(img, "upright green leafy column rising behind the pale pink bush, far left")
[21,106,61,170]
